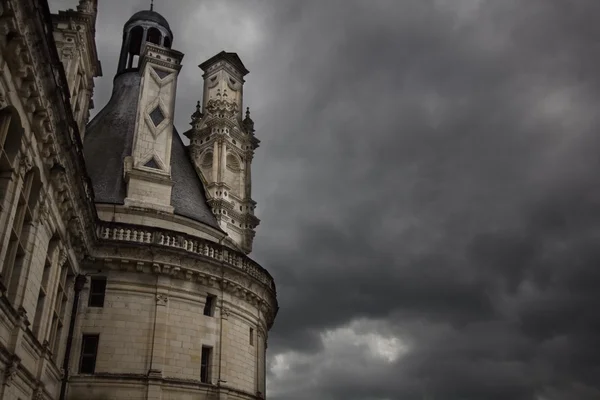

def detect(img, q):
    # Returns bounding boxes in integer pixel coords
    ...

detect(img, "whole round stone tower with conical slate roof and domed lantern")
[65,10,278,400]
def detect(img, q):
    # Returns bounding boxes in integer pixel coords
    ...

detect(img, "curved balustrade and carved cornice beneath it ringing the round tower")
[88,222,277,326]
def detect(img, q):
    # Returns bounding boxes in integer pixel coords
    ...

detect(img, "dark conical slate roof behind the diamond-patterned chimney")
[83,71,220,230]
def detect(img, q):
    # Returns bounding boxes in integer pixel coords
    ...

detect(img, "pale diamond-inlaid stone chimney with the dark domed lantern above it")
[117,11,183,213]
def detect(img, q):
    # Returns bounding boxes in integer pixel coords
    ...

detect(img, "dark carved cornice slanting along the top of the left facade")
[0,0,97,258]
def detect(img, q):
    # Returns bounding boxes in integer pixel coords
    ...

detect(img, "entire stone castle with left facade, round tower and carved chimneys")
[0,0,278,400]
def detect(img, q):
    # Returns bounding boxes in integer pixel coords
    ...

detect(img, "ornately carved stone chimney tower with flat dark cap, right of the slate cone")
[186,51,260,253]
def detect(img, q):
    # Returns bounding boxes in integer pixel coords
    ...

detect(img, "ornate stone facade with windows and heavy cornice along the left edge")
[0,0,96,400]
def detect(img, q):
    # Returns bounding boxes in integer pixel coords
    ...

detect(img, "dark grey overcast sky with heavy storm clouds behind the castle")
[51,0,600,400]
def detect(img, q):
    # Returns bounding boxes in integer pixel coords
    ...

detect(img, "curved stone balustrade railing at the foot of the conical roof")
[97,222,275,291]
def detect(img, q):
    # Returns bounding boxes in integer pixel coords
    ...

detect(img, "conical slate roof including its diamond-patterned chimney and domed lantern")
[84,10,218,229]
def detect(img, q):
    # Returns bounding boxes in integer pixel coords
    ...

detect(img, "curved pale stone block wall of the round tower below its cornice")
[65,261,267,399]
